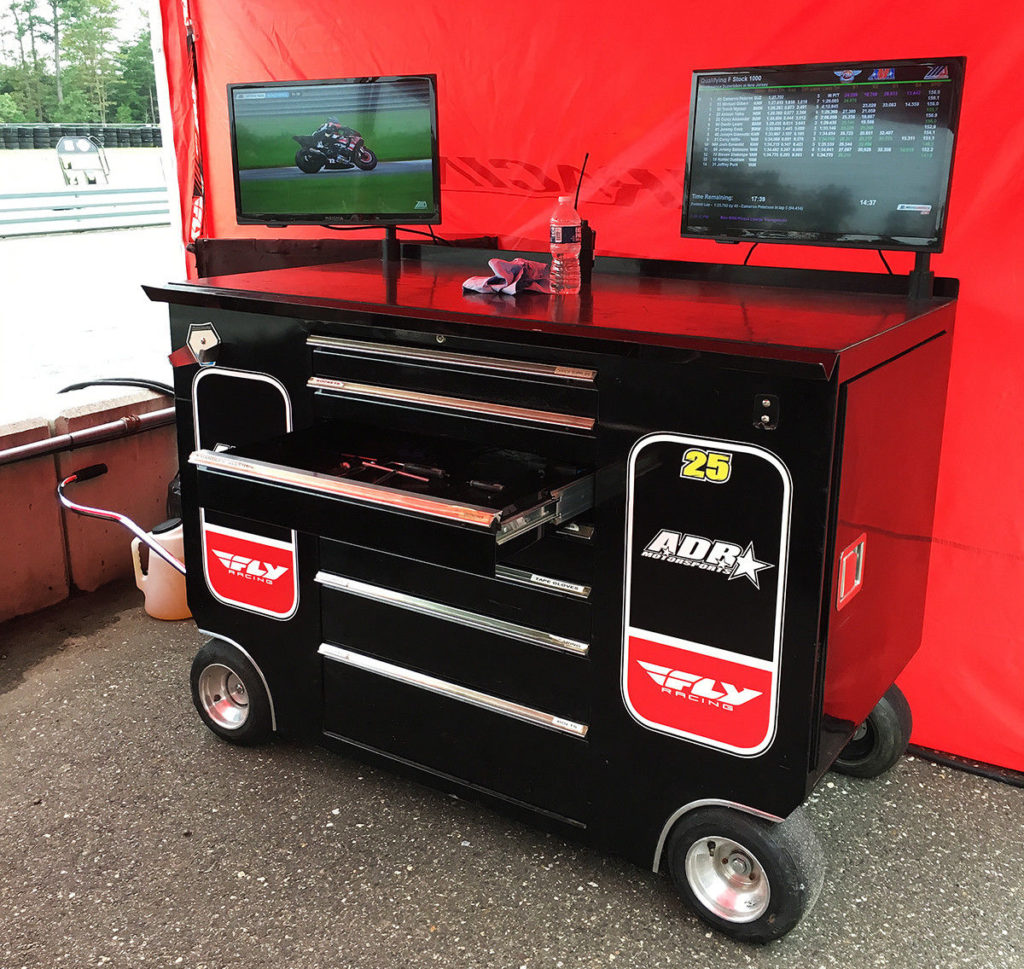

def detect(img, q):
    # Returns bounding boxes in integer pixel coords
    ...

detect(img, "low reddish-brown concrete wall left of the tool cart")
[0,391,177,622]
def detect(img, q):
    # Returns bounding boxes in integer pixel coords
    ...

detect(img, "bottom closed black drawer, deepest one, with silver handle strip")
[321,644,591,825]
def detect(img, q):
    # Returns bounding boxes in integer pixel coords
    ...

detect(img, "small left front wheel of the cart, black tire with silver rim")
[190,639,273,746]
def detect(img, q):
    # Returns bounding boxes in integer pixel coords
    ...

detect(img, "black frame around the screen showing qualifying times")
[680,55,967,252]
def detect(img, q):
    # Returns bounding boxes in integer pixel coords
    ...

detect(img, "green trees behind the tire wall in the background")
[0,0,159,124]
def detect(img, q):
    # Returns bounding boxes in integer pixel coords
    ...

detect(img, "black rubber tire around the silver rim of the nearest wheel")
[666,807,824,943]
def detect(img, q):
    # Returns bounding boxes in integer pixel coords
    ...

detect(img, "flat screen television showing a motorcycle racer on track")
[227,74,441,225]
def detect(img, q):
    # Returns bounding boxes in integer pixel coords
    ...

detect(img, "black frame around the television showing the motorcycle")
[227,74,441,228]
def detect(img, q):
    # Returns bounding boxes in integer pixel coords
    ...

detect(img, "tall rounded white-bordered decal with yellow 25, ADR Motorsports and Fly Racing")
[621,433,793,757]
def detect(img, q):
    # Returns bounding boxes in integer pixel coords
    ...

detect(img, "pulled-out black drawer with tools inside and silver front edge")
[189,423,594,574]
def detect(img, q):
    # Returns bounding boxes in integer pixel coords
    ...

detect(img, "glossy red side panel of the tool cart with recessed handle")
[817,332,952,773]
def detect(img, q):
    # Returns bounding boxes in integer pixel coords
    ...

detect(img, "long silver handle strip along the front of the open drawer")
[188,451,501,530]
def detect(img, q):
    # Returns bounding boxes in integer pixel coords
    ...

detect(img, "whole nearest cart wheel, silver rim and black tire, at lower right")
[668,807,824,942]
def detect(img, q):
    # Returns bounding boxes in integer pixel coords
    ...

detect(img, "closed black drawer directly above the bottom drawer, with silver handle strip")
[316,572,590,721]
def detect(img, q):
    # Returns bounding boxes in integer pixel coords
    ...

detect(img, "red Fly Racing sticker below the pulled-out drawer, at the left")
[202,516,299,619]
